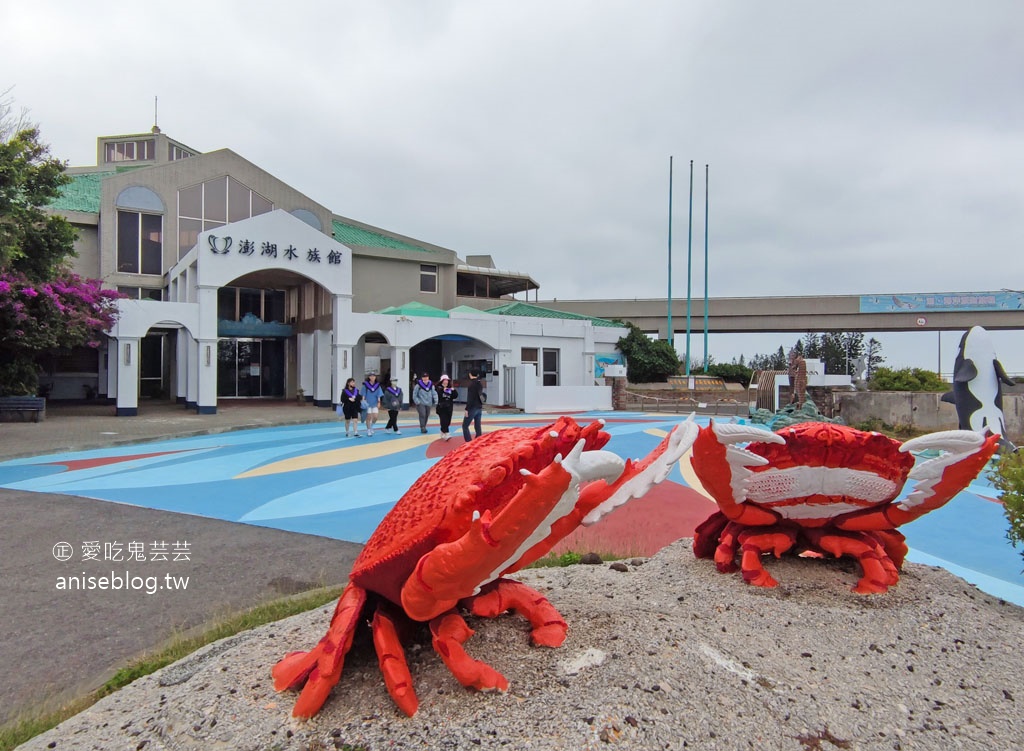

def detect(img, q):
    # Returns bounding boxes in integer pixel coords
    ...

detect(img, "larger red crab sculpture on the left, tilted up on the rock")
[273,417,697,717]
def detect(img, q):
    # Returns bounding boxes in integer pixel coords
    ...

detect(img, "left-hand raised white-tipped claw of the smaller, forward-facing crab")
[690,420,785,525]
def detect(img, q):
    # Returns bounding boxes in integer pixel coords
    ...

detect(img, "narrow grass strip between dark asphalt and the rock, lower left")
[0,587,342,751]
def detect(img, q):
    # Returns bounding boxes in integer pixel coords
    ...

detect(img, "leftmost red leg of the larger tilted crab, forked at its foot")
[271,584,367,717]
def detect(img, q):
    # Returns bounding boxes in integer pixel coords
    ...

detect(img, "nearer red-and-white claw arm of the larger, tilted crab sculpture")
[401,439,624,621]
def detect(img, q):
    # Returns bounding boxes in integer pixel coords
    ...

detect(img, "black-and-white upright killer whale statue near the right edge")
[942,326,1017,451]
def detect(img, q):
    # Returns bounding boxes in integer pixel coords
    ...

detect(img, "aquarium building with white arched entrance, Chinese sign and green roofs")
[48,129,627,416]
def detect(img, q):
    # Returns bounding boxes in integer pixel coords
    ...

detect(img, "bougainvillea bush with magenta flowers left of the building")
[0,272,123,397]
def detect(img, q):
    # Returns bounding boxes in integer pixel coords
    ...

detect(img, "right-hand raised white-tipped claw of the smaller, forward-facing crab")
[836,430,999,532]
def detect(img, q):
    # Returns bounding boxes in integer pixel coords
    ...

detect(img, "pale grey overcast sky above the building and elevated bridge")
[0,0,1024,372]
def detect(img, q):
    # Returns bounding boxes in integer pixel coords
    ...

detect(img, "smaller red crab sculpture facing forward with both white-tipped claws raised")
[691,422,998,593]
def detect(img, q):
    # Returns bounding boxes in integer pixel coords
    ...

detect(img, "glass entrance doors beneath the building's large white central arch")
[217,338,285,399]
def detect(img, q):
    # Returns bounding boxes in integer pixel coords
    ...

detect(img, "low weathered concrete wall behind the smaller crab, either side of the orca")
[834,391,1024,444]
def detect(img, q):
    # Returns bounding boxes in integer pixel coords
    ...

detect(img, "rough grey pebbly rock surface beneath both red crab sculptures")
[22,540,1024,751]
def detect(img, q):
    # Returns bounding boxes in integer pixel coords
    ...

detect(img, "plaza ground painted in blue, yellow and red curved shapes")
[0,412,1024,606]
